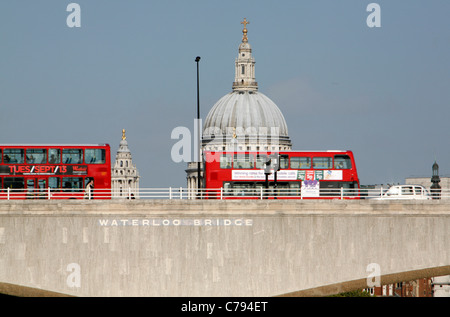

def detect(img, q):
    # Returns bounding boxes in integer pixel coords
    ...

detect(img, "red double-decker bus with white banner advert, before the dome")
[204,151,360,199]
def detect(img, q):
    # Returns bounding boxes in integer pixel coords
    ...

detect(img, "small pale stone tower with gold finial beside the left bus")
[111,129,140,199]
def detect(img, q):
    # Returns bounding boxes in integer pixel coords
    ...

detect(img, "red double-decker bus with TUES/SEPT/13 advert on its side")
[0,144,111,199]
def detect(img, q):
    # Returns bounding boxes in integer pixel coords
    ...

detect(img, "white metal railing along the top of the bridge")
[0,187,450,200]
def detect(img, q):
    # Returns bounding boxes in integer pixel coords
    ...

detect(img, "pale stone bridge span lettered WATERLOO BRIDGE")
[0,200,450,296]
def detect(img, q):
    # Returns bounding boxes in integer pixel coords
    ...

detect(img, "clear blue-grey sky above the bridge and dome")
[0,0,450,187]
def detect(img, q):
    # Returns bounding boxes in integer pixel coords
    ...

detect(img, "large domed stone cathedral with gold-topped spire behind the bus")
[186,19,292,192]
